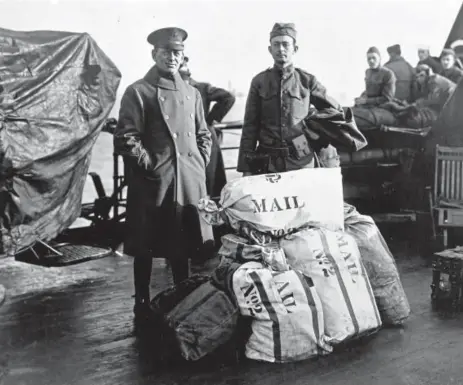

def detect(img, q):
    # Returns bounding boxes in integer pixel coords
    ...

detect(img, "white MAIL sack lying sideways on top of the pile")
[200,168,344,237]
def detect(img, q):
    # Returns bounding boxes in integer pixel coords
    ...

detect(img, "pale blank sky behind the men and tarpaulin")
[0,0,461,117]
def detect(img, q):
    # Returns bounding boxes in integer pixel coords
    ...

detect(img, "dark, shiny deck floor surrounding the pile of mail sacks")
[0,242,463,385]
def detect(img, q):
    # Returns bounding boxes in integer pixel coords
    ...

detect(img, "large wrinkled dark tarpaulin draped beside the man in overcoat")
[0,29,121,255]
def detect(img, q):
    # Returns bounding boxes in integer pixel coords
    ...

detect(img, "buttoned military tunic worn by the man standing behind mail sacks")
[237,66,342,172]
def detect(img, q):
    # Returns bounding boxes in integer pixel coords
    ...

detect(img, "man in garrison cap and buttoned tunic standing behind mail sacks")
[237,23,343,176]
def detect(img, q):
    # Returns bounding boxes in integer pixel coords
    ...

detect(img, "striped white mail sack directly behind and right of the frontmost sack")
[280,229,381,345]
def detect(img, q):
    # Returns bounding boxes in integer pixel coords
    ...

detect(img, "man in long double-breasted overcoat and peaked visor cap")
[114,28,213,319]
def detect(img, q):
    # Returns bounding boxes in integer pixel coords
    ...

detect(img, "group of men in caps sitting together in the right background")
[355,44,463,128]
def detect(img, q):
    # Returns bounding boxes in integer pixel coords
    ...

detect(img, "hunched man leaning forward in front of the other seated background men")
[396,64,456,128]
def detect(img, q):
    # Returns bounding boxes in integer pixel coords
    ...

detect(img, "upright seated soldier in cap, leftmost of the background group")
[355,47,396,108]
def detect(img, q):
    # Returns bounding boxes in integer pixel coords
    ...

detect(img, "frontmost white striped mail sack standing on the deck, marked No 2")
[233,262,332,363]
